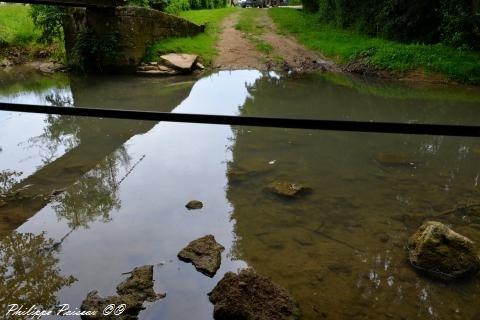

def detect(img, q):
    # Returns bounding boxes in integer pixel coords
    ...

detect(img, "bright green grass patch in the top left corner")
[0,4,40,46]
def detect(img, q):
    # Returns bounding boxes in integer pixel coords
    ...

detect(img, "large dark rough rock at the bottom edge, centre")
[208,269,298,320]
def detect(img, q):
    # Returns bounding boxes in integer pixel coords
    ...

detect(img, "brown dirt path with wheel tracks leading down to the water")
[213,9,339,72]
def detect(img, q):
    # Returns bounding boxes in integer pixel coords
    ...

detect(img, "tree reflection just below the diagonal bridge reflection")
[53,146,130,229]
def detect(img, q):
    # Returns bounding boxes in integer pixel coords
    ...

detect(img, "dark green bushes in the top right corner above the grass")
[308,0,480,49]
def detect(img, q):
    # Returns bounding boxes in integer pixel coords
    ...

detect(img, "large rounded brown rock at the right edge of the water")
[408,221,480,280]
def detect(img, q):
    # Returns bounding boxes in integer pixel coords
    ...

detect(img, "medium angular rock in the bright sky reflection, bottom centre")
[178,235,225,277]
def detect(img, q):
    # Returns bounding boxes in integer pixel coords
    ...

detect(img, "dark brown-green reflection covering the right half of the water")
[227,72,480,319]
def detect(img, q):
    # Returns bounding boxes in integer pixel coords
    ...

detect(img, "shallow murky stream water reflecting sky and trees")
[0,67,480,320]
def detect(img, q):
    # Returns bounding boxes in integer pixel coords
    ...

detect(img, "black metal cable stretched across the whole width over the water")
[0,103,480,137]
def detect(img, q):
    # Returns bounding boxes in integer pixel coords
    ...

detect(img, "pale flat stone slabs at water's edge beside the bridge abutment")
[137,53,205,75]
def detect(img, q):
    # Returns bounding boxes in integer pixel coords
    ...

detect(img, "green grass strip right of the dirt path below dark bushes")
[269,8,480,84]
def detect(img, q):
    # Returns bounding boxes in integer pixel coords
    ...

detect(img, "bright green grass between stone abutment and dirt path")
[145,8,238,66]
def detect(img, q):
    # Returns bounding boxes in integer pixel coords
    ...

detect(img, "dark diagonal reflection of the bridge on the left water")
[0,76,193,239]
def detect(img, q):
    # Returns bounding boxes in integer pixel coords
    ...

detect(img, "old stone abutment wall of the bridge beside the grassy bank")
[64,7,204,71]
